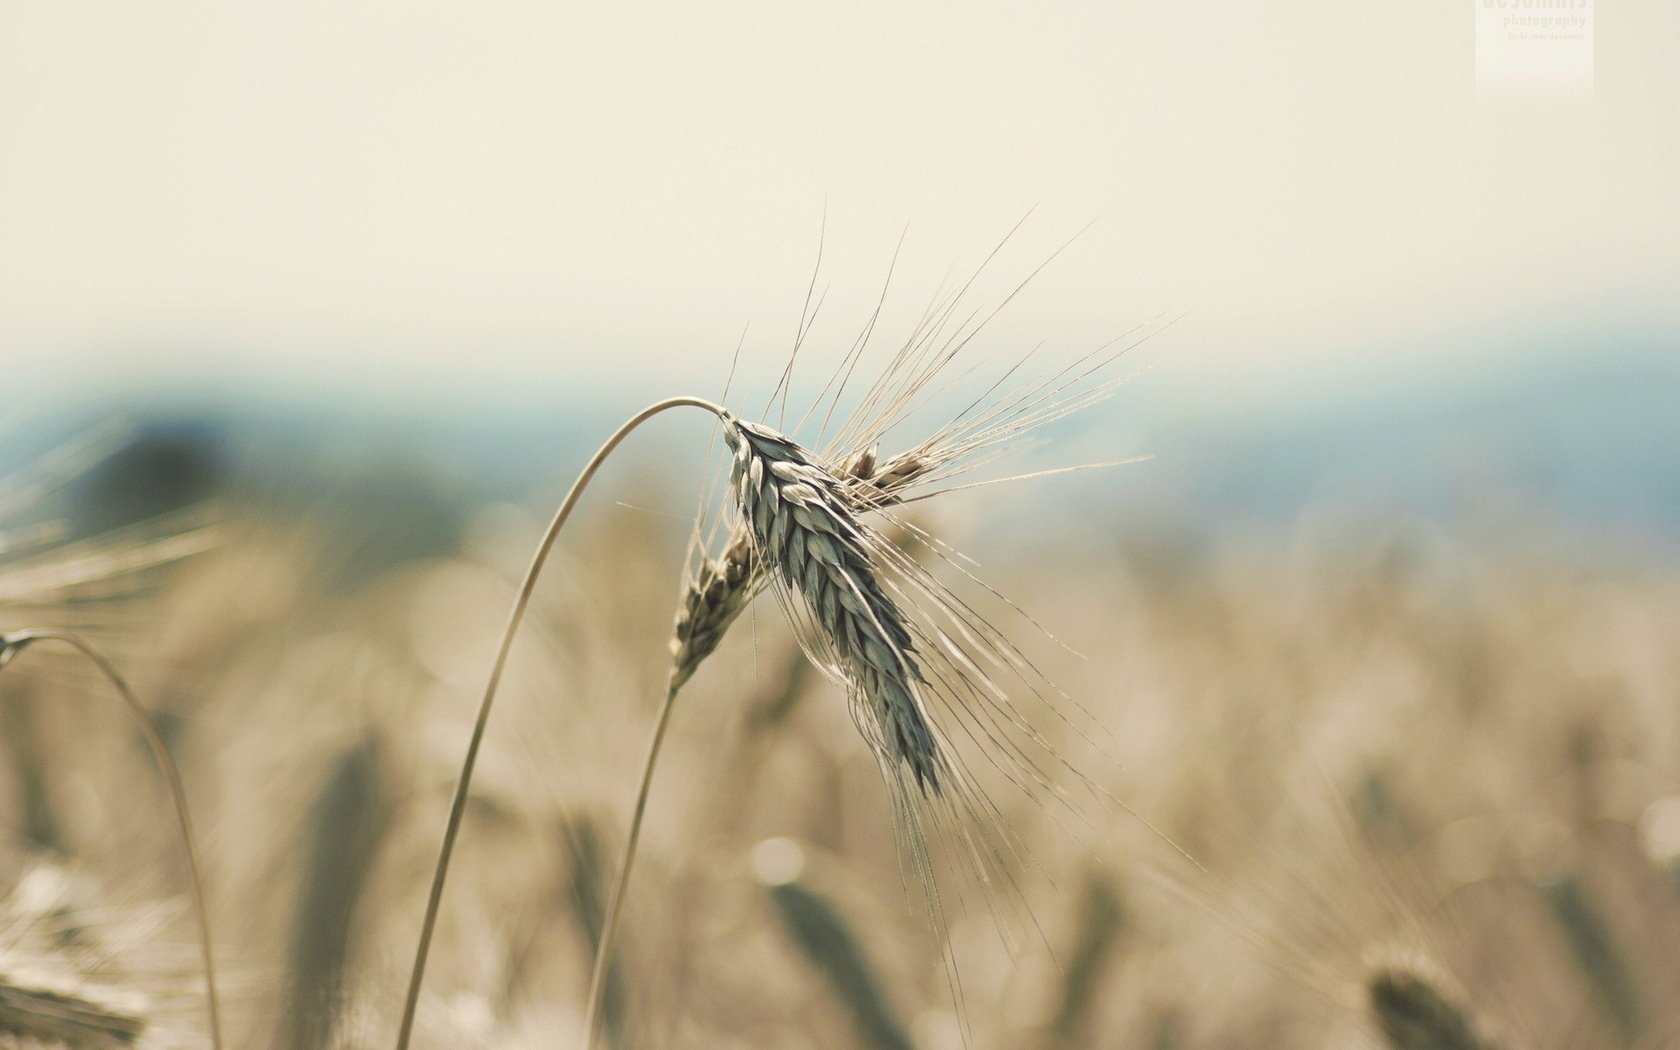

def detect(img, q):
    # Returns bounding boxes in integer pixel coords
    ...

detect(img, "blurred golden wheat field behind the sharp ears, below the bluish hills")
[0,440,1680,1050]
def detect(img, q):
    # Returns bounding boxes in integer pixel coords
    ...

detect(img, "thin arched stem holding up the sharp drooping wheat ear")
[396,396,722,1050]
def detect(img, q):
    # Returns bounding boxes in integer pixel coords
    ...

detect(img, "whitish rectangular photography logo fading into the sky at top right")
[1473,0,1593,102]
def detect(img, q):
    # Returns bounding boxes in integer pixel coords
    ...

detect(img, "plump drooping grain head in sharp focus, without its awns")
[722,413,944,795]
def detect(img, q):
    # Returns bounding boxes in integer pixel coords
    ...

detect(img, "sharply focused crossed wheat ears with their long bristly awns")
[651,309,1183,1011]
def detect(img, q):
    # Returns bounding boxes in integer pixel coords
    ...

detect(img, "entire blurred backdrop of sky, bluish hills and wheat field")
[0,0,1680,1048]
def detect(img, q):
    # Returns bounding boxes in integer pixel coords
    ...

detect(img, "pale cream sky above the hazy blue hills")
[0,0,1680,404]
